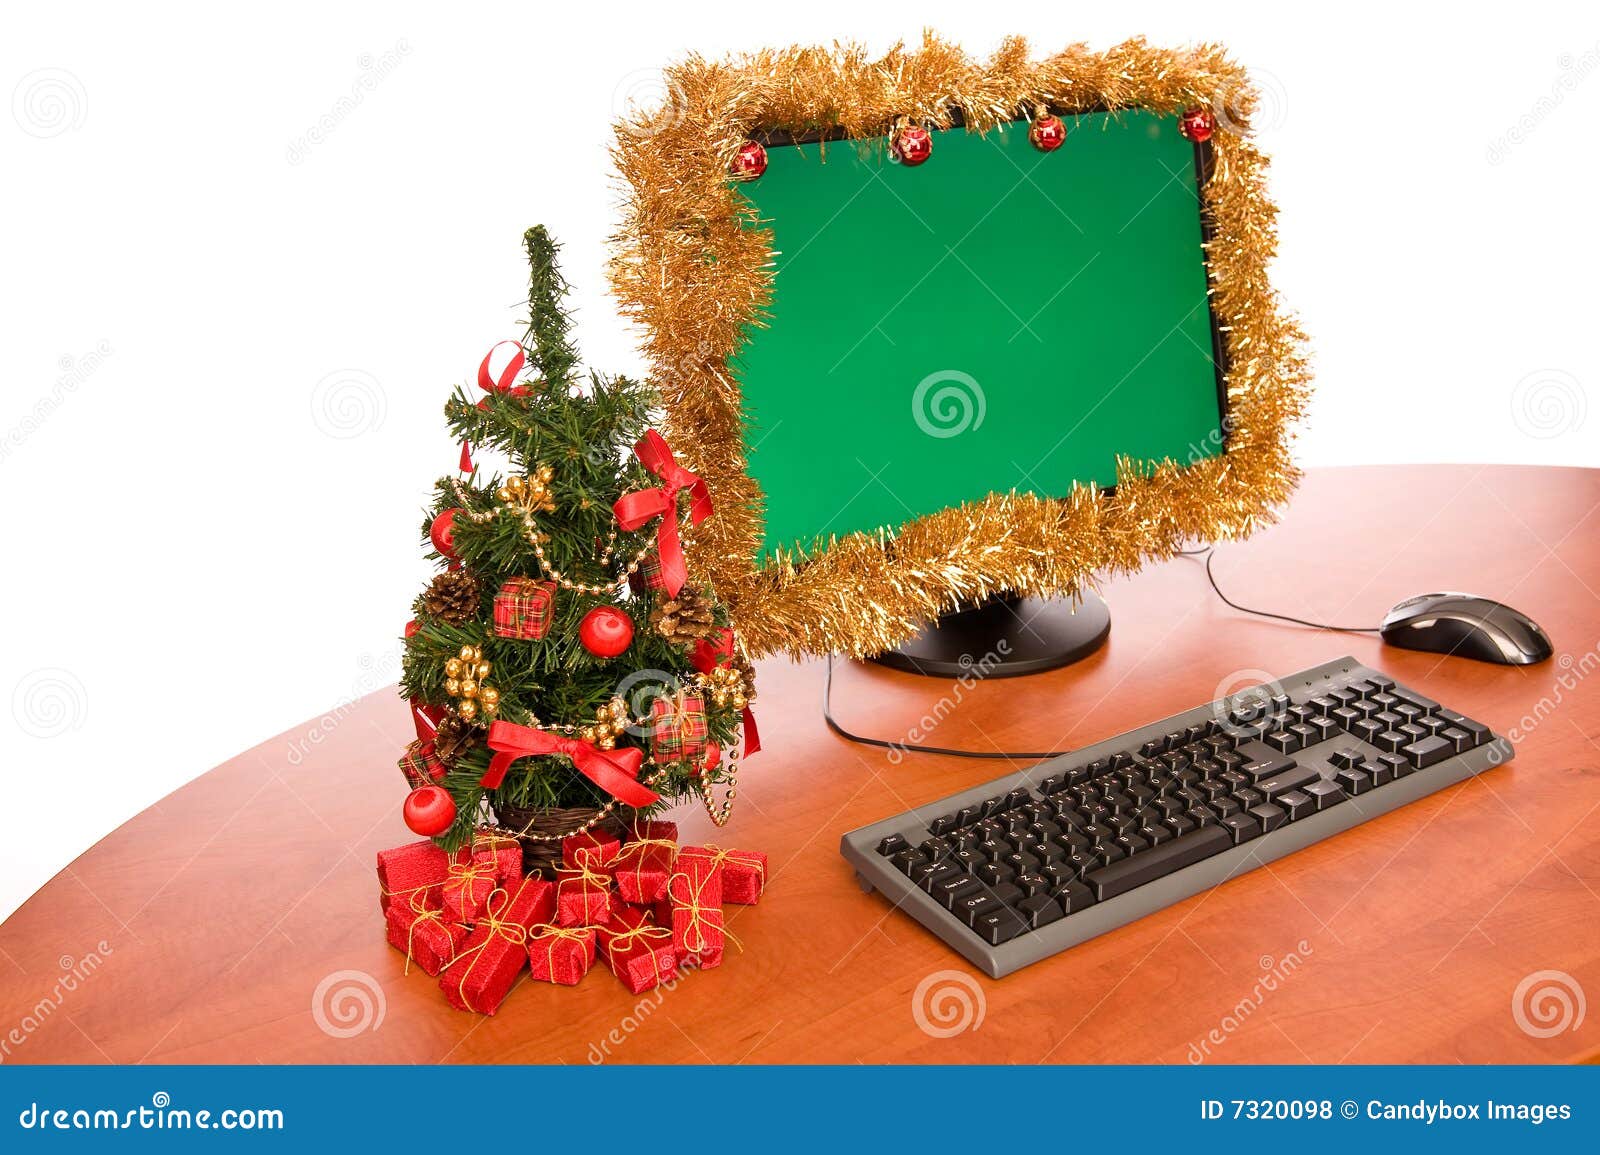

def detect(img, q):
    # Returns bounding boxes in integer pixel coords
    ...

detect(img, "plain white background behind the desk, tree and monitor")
[0,0,1600,915]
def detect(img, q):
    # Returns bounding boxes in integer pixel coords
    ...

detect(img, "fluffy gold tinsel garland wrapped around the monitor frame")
[613,35,1310,656]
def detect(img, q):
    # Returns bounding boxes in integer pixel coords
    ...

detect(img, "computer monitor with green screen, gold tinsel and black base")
[611,37,1309,673]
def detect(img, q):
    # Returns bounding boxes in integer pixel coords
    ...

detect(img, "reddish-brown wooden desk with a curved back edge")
[0,467,1600,1064]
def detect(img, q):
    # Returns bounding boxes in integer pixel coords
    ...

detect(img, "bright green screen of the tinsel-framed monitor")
[733,110,1224,557]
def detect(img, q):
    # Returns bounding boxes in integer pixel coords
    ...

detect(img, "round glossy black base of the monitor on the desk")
[867,592,1110,678]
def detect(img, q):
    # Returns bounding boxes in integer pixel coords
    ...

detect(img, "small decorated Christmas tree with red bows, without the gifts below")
[400,227,755,861]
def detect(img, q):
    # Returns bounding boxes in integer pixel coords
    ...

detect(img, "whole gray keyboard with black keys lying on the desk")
[840,657,1512,979]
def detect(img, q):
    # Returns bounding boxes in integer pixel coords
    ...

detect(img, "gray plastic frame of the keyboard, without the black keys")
[838,657,1514,979]
